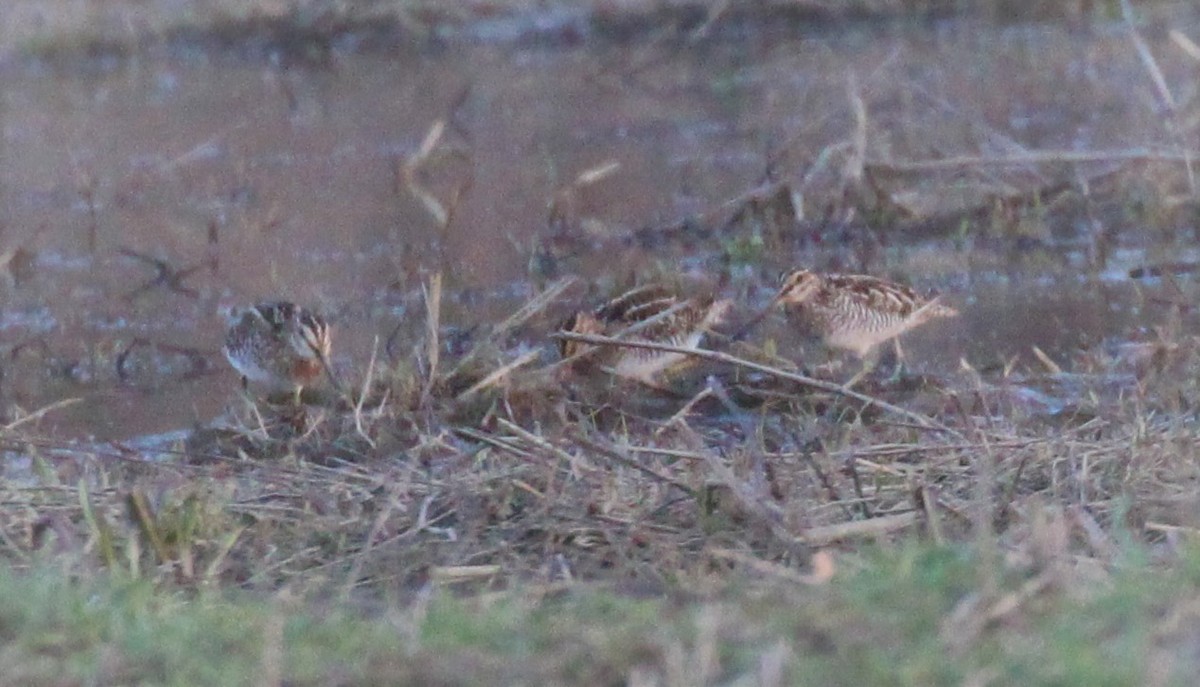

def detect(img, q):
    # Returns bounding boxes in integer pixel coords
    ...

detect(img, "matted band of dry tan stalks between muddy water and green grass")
[2,271,1200,597]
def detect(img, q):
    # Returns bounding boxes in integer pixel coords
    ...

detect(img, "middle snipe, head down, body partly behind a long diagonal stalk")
[558,286,731,384]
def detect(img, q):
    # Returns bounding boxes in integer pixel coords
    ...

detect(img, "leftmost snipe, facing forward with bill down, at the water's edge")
[222,301,337,404]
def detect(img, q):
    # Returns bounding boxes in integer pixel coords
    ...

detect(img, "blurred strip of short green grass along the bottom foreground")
[0,544,1200,686]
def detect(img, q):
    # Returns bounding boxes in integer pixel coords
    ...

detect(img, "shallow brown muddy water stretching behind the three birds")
[0,12,1200,438]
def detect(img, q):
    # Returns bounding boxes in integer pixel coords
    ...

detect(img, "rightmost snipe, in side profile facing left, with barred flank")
[772,269,959,386]
